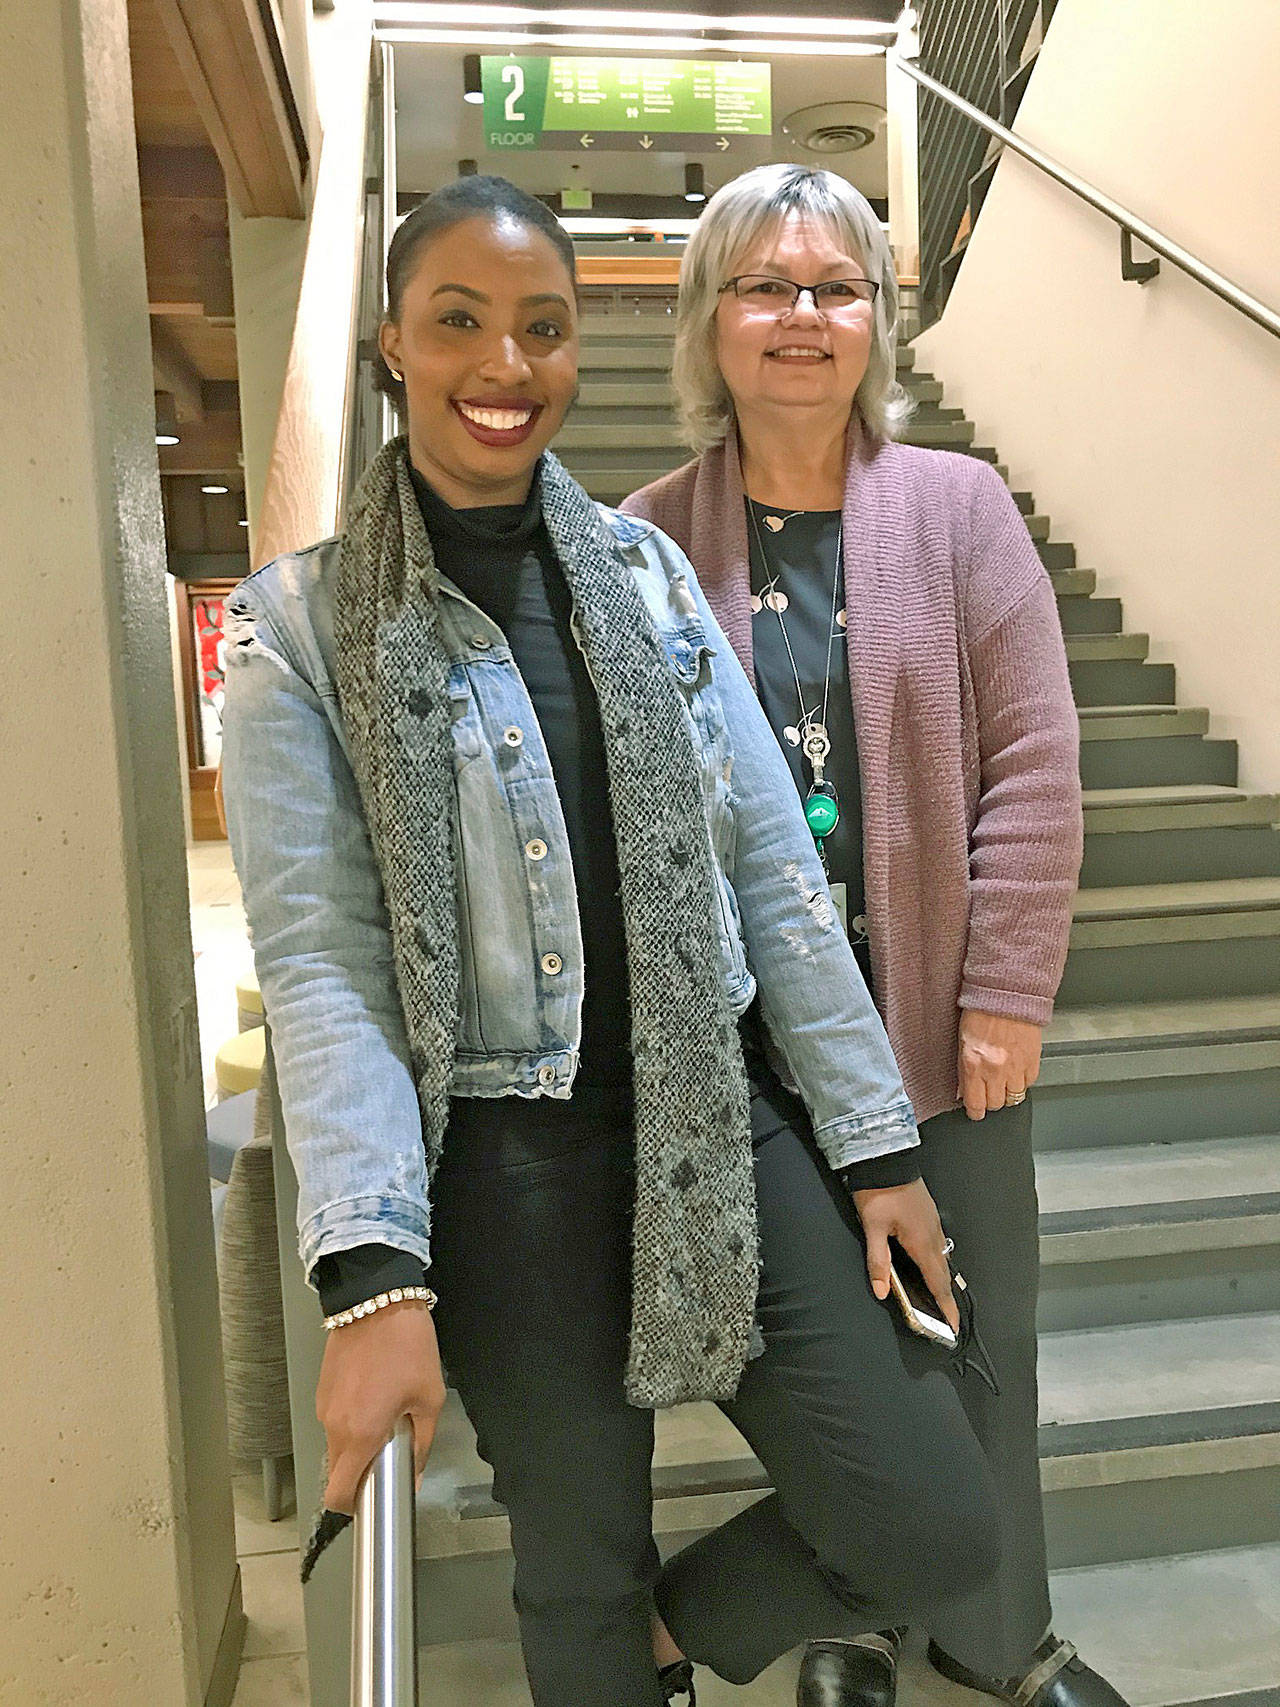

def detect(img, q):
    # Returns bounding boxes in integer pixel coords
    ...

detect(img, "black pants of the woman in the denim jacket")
[433,1092,998,1707]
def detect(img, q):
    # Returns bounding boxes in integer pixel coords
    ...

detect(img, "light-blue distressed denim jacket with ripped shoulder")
[224,510,918,1272]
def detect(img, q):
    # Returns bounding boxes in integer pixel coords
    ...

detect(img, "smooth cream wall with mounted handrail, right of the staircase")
[918,0,1280,789]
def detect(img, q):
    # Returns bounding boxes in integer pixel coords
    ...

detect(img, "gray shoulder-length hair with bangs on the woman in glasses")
[671,166,911,456]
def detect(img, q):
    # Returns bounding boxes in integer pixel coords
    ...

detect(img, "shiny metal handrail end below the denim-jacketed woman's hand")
[352,1417,418,1707]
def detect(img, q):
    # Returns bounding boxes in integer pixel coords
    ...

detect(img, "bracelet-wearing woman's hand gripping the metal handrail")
[316,1301,444,1514]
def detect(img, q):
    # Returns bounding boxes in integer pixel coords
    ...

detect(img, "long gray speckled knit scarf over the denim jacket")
[335,439,758,1407]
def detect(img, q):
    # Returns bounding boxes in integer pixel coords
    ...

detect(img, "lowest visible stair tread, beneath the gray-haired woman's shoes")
[422,1545,1280,1707]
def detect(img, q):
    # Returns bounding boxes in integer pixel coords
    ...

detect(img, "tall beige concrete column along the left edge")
[0,0,242,1707]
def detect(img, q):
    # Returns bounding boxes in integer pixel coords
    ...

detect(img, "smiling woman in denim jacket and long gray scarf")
[225,178,995,1707]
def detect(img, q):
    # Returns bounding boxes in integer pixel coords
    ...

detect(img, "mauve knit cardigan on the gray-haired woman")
[621,428,1084,1120]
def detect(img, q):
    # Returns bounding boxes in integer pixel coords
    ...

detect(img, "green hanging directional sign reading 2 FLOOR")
[481,55,773,152]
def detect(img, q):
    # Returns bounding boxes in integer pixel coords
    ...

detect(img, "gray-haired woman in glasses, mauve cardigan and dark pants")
[623,166,1123,1707]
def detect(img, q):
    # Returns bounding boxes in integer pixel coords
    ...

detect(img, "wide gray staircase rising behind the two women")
[407,314,1280,1707]
